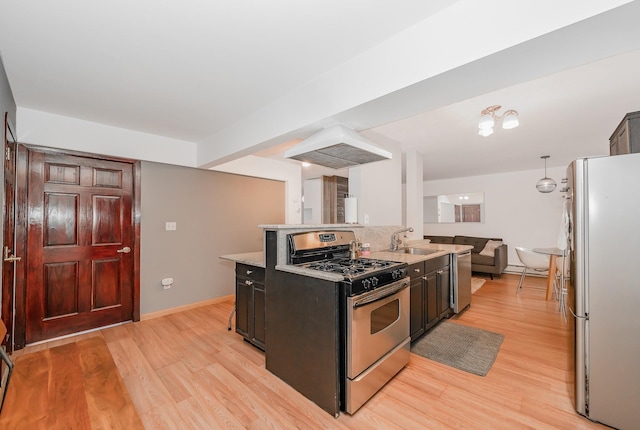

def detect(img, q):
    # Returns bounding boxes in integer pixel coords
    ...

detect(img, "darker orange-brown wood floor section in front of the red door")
[0,336,144,430]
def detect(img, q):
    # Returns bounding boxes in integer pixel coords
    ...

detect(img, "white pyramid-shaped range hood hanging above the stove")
[284,124,392,169]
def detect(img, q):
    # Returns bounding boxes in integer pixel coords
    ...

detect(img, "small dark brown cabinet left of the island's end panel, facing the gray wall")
[236,263,265,351]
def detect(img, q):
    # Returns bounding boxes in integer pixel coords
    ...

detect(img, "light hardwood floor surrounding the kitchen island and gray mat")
[3,275,607,430]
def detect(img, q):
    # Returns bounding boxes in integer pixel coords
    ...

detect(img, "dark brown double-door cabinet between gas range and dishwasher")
[407,255,452,341]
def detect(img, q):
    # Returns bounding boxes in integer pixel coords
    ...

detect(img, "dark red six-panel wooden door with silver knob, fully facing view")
[25,150,135,343]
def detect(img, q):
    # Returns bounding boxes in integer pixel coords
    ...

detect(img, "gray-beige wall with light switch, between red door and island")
[140,162,285,316]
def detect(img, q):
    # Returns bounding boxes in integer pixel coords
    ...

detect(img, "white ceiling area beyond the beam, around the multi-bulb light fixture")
[372,51,640,179]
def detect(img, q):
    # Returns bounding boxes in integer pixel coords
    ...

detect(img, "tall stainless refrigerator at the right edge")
[566,154,640,429]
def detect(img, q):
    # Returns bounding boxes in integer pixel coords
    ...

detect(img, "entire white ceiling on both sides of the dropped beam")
[0,0,640,180]
